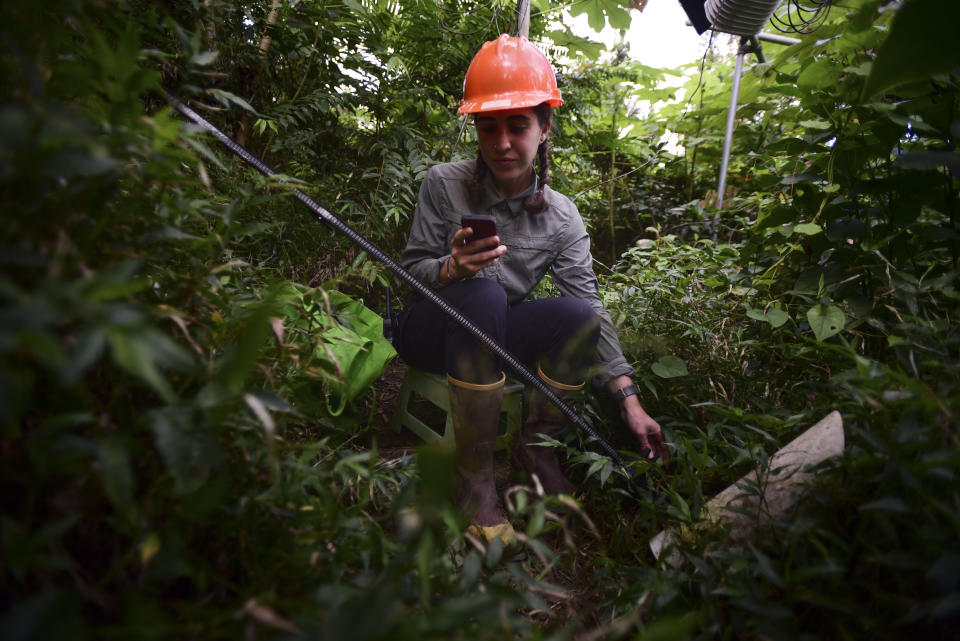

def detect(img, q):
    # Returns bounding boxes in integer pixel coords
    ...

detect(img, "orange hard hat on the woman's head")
[457,34,563,114]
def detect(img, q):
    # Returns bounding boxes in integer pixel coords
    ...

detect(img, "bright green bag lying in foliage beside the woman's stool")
[285,283,397,416]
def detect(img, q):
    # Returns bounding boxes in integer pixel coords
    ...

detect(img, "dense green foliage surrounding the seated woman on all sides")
[0,0,960,639]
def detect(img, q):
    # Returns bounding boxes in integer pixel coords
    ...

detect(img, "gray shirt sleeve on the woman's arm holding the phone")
[400,167,450,289]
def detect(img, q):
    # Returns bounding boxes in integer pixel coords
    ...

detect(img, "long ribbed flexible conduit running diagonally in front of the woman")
[166,92,639,492]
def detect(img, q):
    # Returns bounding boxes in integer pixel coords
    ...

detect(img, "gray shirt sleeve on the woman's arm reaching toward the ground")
[552,213,634,380]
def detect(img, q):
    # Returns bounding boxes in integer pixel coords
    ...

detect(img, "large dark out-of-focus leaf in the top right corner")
[863,0,960,99]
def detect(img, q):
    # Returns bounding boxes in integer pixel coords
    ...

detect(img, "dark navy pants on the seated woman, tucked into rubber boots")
[395,278,600,385]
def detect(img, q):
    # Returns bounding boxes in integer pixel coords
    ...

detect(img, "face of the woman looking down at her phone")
[474,107,550,198]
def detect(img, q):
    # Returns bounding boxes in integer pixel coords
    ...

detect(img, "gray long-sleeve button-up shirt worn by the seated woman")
[400,160,634,380]
